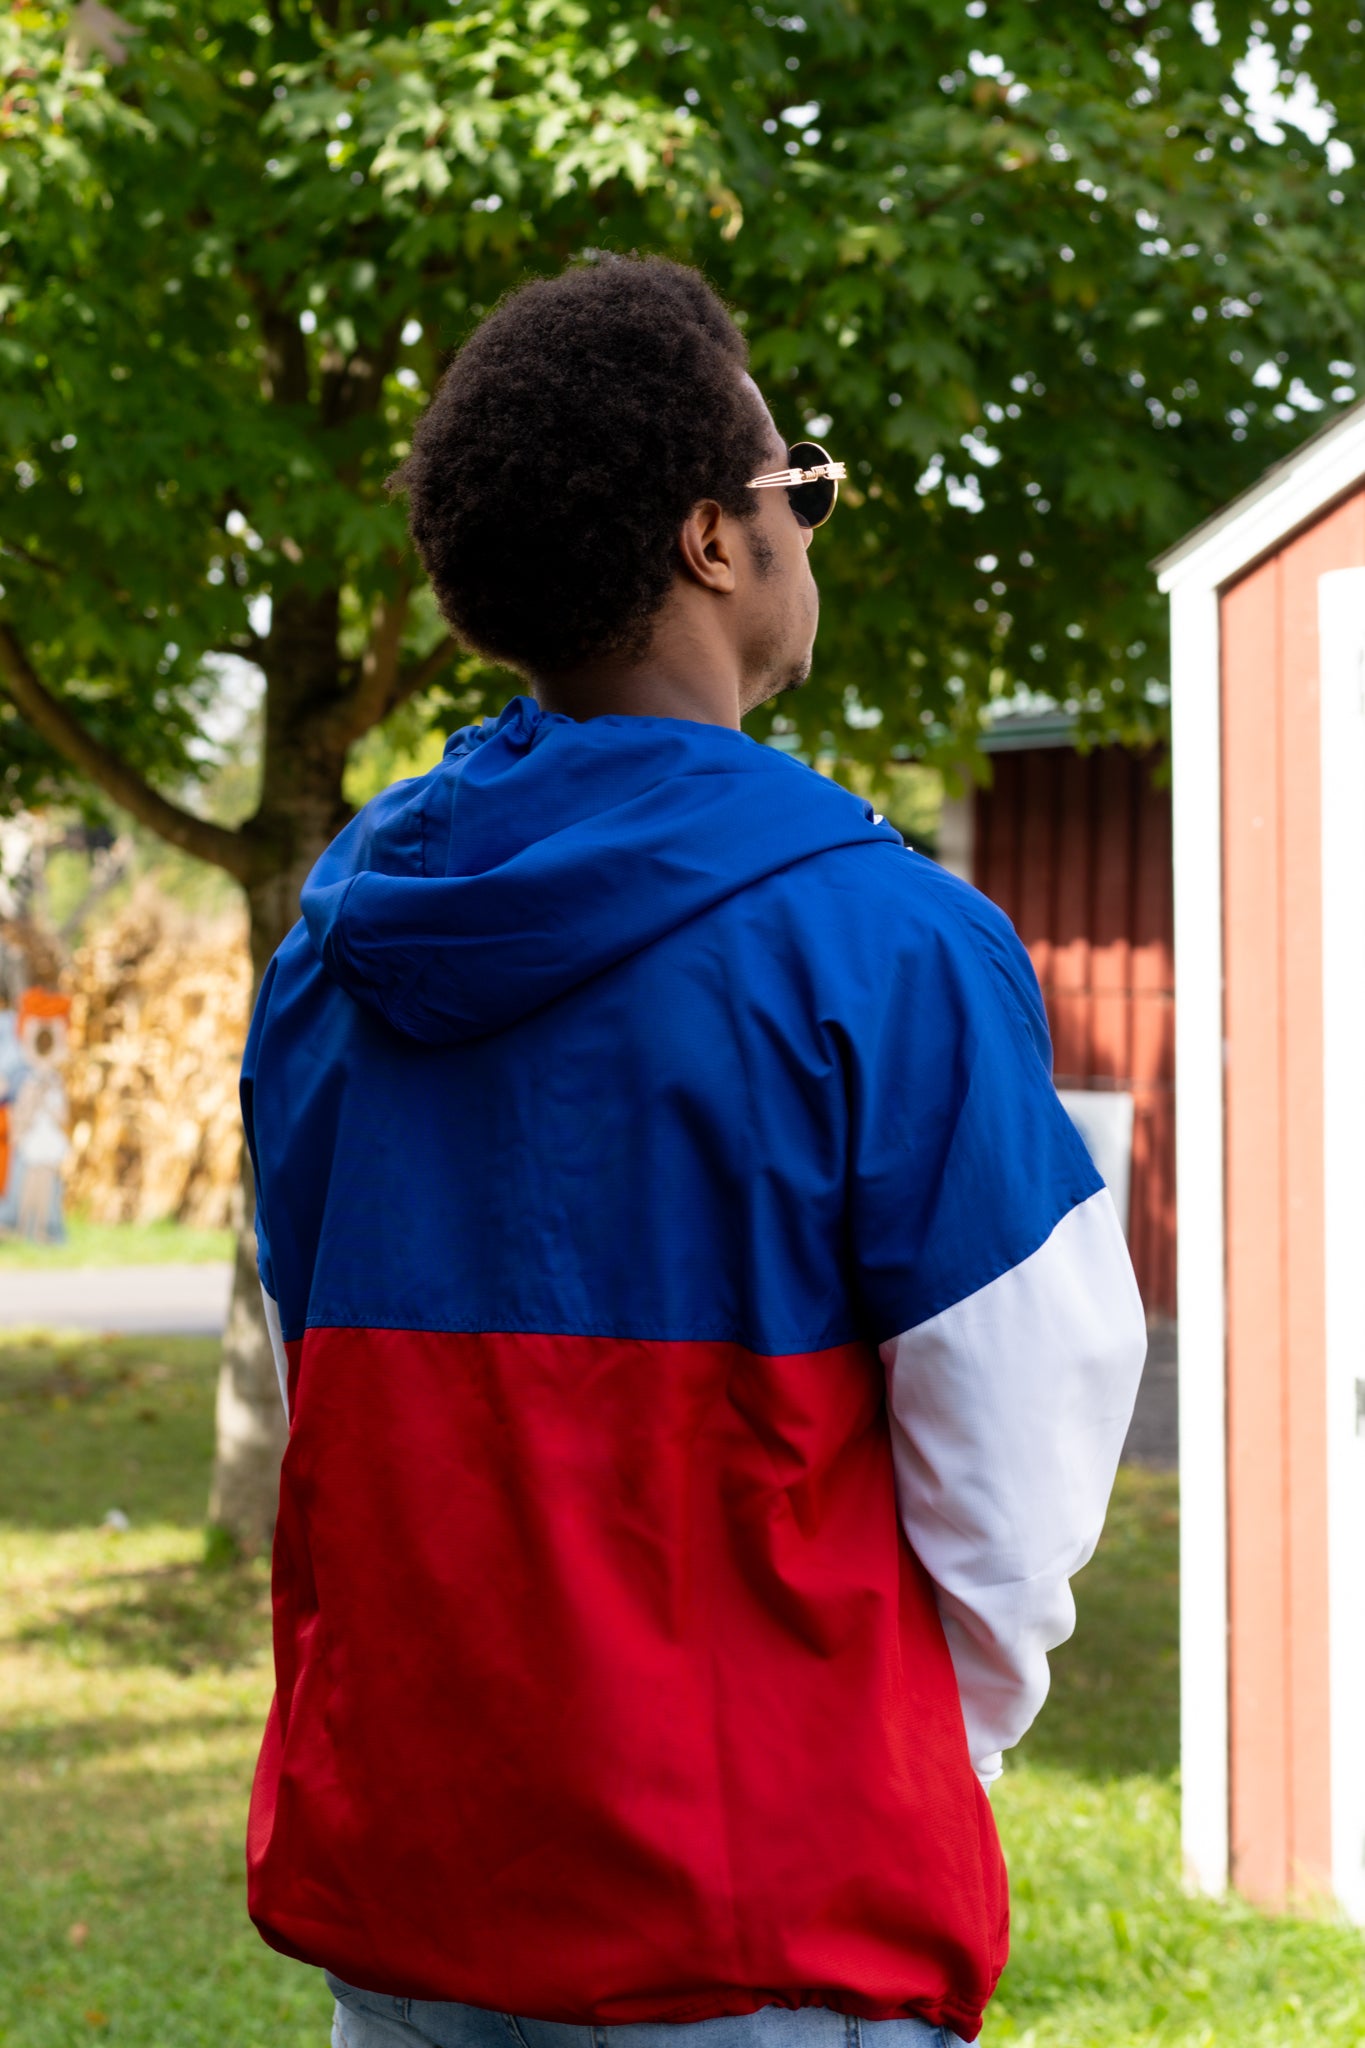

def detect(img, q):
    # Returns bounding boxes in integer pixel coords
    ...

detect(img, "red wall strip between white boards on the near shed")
[1222,479,1365,1903]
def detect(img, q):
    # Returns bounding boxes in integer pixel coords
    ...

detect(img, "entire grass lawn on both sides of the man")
[0,1337,1365,2048]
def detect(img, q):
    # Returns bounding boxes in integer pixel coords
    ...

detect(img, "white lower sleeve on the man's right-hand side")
[882,1188,1146,1784]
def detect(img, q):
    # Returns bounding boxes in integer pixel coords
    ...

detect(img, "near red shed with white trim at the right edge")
[1156,406,1365,1921]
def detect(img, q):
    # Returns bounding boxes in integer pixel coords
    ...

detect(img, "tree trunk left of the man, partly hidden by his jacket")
[209,592,350,1556]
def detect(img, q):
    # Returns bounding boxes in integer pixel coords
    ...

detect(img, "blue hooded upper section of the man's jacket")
[241,698,1099,1356]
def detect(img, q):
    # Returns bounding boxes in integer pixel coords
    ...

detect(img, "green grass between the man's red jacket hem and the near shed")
[984,1468,1365,2048]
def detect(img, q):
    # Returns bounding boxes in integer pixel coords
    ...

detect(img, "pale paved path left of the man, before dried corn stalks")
[0,1260,231,1337]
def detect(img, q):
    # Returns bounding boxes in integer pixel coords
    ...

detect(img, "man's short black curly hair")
[389,256,769,676]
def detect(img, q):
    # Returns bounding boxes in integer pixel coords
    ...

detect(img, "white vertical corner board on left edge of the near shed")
[1171,584,1228,1892]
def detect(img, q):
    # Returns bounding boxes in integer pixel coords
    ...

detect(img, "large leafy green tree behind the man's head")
[0,0,1365,1544]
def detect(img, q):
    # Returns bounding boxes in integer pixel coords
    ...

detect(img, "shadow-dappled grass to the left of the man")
[0,1337,332,2048]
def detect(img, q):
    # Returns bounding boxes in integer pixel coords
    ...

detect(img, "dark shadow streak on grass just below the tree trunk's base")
[16,1565,270,1677]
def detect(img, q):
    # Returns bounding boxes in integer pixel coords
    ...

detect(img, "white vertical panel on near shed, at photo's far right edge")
[1318,567,1365,1921]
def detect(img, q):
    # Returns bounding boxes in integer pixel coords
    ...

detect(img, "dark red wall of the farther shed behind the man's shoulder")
[974,748,1175,1317]
